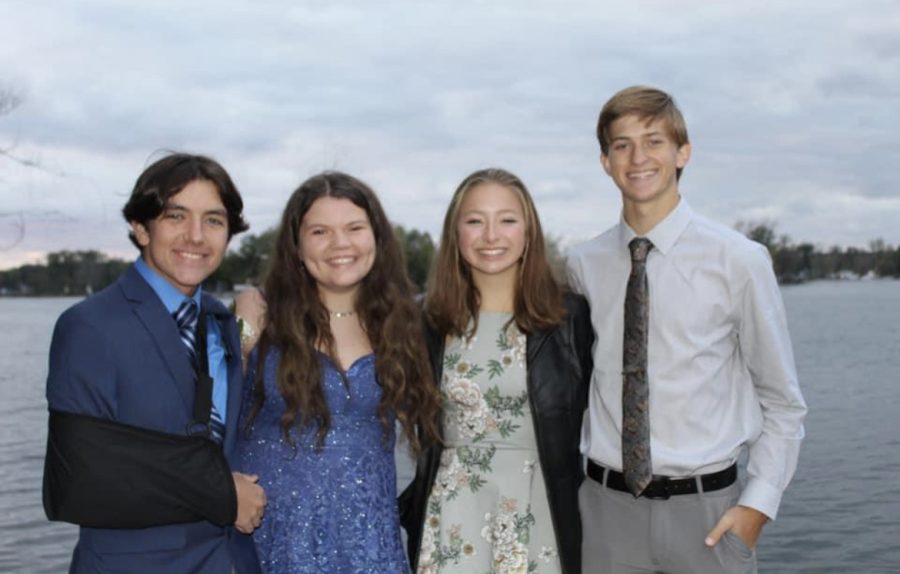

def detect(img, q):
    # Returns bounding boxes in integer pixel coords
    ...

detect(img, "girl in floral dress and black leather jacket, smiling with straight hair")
[401,169,593,574]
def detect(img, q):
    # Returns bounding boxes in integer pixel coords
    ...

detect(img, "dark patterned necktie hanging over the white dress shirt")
[622,237,653,497]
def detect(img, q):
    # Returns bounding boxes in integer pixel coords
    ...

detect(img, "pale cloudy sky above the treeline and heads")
[0,0,900,268]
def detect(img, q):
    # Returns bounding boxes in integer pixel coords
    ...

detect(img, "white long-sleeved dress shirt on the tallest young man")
[569,198,806,519]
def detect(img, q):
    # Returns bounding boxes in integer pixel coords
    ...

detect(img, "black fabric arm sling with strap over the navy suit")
[43,311,237,528]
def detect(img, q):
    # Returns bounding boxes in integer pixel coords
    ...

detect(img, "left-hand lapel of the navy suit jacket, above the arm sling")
[121,266,194,417]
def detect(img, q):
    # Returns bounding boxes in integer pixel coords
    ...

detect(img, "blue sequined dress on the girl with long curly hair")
[238,351,409,574]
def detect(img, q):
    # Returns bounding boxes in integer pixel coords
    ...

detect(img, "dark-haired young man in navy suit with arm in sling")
[45,154,265,574]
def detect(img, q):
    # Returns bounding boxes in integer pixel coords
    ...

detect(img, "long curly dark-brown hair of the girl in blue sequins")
[246,172,440,453]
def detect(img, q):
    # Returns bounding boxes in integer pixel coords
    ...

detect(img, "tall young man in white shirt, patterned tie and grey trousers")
[569,86,806,574]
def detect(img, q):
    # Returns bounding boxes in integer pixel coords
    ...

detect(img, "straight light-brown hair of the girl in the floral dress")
[425,168,565,337]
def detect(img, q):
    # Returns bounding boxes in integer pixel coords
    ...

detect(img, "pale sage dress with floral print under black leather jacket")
[418,312,560,574]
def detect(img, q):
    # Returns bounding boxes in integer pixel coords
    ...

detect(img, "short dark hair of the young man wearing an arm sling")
[122,153,249,250]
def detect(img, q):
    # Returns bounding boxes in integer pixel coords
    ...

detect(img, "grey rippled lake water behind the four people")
[0,281,900,574]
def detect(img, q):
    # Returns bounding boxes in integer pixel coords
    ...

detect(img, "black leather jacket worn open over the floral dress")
[400,293,594,574]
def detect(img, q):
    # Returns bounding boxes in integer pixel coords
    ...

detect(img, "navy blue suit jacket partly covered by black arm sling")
[47,266,259,574]
